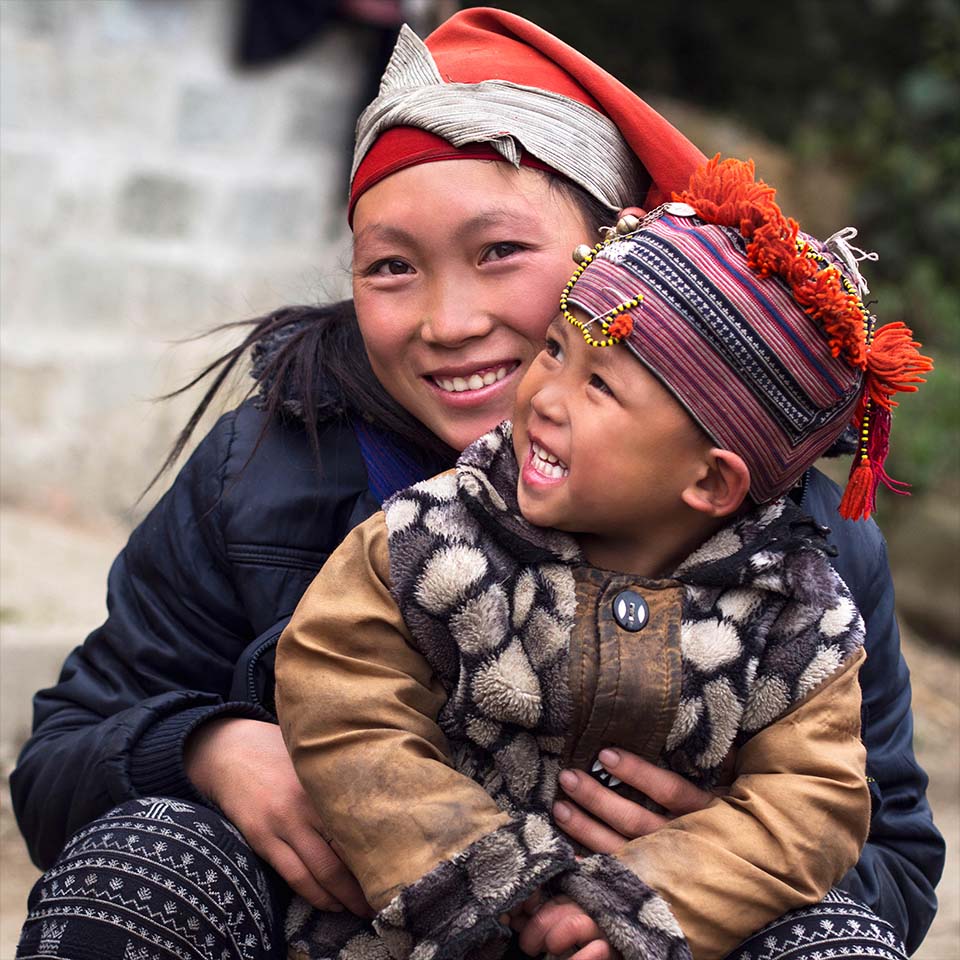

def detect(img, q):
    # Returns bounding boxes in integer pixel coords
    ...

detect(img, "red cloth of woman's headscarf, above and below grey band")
[349,7,705,218]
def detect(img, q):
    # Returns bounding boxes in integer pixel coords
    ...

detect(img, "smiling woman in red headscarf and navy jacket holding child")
[11,9,942,958]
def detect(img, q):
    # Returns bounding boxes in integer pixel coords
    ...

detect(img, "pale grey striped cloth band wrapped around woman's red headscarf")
[350,26,647,210]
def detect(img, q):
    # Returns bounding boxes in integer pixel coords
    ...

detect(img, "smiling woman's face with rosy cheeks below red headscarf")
[353,160,594,450]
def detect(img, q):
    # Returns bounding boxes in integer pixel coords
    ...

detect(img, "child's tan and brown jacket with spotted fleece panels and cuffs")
[277,423,869,960]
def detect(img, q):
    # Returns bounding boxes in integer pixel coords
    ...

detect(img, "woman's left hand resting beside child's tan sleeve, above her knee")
[184,717,373,917]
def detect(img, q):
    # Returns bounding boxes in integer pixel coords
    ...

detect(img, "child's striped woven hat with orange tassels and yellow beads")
[560,156,933,519]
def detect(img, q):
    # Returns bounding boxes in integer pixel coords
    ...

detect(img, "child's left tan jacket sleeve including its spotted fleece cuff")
[277,514,573,957]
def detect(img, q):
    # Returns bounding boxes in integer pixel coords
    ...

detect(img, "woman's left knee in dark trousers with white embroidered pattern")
[17,798,283,960]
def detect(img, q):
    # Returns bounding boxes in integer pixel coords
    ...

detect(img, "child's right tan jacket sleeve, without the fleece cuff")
[608,651,869,960]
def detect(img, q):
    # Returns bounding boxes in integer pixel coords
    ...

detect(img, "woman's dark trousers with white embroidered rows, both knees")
[17,799,906,960]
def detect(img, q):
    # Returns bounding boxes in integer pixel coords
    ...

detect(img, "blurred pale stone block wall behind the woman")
[0,0,365,519]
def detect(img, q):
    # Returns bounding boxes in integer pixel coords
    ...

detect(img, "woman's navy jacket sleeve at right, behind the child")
[802,470,945,952]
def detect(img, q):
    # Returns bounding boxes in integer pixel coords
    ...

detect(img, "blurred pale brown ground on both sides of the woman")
[0,508,960,960]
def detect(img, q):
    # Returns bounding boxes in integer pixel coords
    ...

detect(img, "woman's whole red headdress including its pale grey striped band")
[349,7,704,219]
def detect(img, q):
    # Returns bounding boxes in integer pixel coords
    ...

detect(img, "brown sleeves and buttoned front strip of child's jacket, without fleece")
[277,514,869,960]
